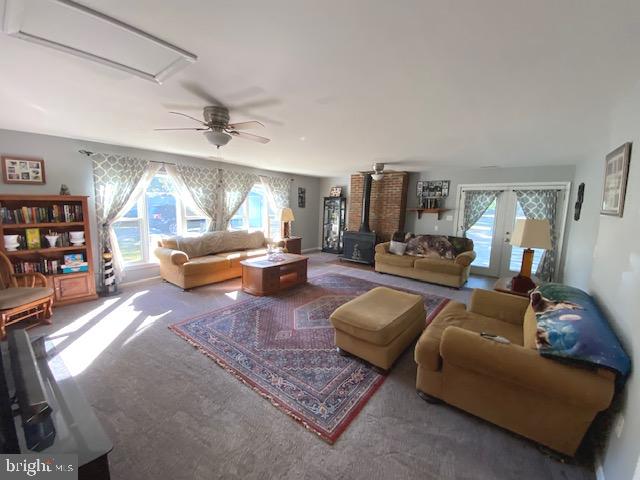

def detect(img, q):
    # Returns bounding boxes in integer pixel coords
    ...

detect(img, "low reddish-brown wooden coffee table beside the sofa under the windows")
[240,253,308,296]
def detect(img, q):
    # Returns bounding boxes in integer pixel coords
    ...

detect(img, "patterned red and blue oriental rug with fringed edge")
[169,273,449,443]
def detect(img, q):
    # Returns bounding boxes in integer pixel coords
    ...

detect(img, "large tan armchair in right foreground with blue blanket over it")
[415,290,615,455]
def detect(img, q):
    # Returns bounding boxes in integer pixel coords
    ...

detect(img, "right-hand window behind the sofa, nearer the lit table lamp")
[229,183,280,240]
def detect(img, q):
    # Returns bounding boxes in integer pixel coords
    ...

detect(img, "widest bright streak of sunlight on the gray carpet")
[58,290,149,376]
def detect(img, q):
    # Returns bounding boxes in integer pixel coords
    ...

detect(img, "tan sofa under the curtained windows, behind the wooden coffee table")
[154,231,267,290]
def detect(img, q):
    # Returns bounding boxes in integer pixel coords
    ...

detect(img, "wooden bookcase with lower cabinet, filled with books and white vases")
[0,195,97,307]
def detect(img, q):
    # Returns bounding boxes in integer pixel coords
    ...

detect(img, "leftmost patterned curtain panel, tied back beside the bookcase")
[91,153,161,280]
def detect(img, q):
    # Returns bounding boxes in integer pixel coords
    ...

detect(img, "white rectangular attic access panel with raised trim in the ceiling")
[0,0,197,83]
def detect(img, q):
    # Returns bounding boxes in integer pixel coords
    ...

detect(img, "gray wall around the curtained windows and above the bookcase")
[0,130,320,281]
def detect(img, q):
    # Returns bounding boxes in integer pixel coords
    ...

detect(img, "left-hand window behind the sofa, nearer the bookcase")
[113,173,209,265]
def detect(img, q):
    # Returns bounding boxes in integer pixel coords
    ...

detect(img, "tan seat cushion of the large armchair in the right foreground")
[415,302,523,371]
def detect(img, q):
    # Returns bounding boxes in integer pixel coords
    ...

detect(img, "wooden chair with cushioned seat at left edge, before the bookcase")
[0,252,53,340]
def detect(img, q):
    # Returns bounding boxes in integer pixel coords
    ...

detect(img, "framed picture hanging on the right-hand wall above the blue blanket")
[600,142,631,217]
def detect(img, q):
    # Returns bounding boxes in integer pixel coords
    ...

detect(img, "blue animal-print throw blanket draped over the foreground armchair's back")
[531,283,631,378]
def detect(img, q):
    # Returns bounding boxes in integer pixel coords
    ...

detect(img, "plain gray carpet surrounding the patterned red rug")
[23,254,594,480]
